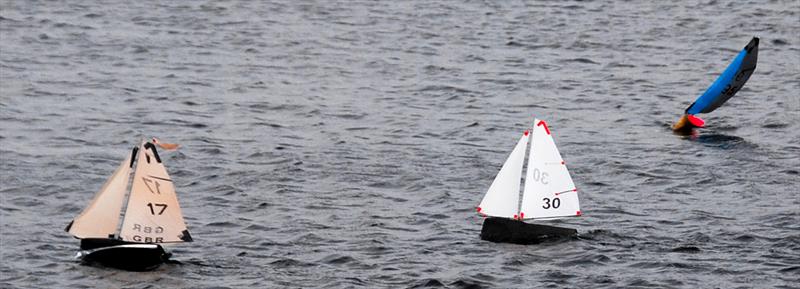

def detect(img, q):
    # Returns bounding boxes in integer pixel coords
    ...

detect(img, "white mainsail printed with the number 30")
[520,119,581,219]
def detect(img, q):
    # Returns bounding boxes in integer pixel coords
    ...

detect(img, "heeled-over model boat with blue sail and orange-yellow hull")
[672,37,758,133]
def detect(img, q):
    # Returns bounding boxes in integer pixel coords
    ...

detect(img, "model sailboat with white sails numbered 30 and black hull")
[477,119,581,244]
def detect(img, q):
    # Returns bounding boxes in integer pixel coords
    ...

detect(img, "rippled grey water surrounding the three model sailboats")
[0,0,800,288]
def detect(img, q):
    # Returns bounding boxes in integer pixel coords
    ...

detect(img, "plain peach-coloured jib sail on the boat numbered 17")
[69,154,131,239]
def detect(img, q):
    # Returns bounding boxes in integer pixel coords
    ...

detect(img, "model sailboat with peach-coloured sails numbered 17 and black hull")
[66,139,192,271]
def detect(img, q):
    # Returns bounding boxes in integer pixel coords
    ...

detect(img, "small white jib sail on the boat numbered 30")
[478,131,528,218]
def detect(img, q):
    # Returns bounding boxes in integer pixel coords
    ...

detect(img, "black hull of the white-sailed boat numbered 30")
[481,217,578,245]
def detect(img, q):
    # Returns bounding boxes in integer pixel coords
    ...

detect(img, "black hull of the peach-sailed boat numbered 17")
[80,243,172,271]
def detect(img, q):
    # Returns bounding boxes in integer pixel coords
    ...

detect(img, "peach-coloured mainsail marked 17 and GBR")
[120,143,191,243]
